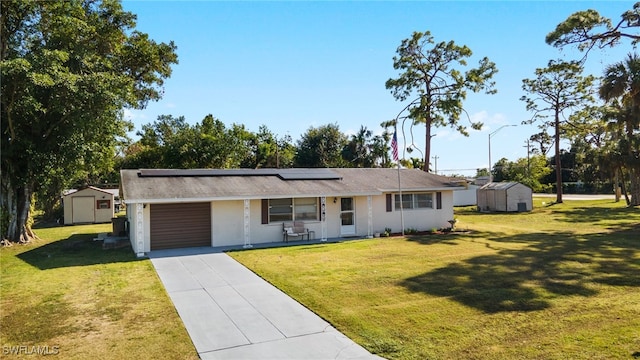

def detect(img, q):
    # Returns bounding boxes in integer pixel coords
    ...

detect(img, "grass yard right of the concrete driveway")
[230,199,640,359]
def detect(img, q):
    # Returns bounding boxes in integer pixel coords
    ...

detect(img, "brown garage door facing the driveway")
[150,203,211,250]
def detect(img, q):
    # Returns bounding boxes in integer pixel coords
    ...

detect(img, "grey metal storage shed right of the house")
[477,182,533,212]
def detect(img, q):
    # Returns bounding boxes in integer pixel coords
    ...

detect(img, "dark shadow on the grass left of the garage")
[17,234,138,270]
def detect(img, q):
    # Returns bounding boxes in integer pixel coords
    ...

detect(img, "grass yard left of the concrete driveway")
[0,224,198,359]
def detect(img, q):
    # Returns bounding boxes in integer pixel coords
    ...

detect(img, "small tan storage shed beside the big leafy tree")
[62,186,114,225]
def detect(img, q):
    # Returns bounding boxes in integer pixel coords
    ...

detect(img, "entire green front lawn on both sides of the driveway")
[0,200,640,359]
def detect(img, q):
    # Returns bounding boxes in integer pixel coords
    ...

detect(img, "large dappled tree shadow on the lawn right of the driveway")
[400,226,640,313]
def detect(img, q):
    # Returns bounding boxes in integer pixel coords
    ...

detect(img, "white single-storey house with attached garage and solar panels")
[121,168,464,256]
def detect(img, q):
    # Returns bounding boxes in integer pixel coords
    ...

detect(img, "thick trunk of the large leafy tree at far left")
[1,172,36,243]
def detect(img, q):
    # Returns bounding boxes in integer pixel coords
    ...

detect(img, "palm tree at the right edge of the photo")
[599,54,640,206]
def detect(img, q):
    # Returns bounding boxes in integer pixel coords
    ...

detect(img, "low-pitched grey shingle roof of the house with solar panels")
[120,168,464,203]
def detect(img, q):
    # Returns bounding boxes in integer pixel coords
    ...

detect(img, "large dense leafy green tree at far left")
[0,0,177,242]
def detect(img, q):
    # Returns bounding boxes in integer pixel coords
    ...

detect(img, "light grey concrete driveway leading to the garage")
[150,248,381,359]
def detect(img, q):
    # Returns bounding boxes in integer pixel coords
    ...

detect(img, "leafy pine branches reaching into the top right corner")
[545,2,640,53]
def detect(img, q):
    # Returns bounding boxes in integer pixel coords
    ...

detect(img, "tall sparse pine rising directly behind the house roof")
[386,31,498,172]
